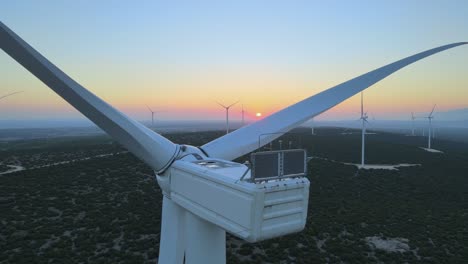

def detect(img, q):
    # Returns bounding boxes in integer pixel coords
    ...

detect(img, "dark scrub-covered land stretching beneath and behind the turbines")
[0,128,468,263]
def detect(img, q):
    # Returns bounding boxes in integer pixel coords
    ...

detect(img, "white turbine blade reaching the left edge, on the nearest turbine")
[0,22,179,171]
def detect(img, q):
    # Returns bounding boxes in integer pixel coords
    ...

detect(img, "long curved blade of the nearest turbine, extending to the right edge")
[201,42,468,160]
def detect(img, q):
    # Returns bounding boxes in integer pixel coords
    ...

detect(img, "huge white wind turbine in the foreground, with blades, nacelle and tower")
[0,22,468,264]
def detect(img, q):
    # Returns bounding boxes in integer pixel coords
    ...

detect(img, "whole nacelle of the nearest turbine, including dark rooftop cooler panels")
[157,147,310,242]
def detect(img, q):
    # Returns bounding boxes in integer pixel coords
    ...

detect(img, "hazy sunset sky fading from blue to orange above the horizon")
[0,0,468,125]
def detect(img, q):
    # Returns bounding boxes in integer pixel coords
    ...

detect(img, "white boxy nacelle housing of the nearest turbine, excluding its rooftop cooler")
[169,159,310,242]
